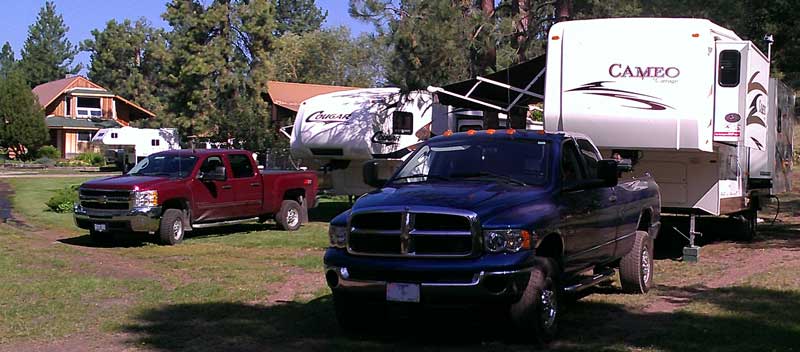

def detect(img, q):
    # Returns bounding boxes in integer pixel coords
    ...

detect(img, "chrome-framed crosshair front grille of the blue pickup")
[347,211,478,257]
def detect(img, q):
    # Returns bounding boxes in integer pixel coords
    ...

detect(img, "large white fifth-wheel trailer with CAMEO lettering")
[544,18,794,255]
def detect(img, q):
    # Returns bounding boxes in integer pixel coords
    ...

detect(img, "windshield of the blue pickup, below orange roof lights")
[390,140,550,186]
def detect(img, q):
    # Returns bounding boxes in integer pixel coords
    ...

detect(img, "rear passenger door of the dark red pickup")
[228,154,264,218]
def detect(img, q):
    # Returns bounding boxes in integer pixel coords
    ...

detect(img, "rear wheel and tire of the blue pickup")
[619,231,653,294]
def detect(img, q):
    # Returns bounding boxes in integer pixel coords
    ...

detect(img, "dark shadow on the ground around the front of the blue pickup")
[123,287,800,352]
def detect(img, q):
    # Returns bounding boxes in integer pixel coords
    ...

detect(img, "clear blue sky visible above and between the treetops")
[0,0,372,72]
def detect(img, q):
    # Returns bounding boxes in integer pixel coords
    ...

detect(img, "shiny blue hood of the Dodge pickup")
[353,182,551,223]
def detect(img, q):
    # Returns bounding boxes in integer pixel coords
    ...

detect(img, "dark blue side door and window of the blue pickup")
[559,139,618,271]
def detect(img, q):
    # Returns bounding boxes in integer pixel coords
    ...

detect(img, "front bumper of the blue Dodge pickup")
[325,249,535,304]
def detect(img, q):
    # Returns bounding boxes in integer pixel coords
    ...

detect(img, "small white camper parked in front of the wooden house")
[92,126,181,169]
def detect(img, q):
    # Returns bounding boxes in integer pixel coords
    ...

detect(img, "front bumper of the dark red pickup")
[74,205,161,233]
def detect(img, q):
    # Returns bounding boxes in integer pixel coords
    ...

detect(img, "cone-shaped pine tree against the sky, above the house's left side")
[20,1,82,87]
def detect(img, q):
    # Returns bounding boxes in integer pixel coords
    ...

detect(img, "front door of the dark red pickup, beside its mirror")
[191,155,235,222]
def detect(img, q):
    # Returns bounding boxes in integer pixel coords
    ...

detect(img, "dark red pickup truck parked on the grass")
[74,149,318,245]
